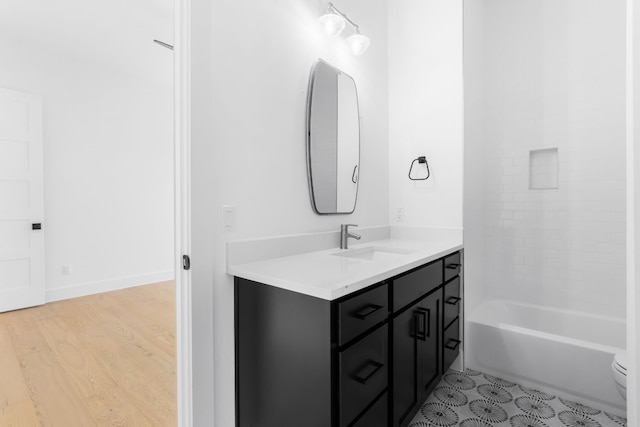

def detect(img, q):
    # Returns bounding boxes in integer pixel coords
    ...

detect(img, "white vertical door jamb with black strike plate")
[173,0,195,427]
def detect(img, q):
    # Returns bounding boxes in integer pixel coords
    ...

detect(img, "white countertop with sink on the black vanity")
[227,236,462,301]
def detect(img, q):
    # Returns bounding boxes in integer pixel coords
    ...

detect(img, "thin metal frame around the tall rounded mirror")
[305,58,362,215]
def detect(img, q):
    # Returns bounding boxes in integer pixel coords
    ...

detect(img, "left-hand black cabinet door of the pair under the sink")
[392,303,424,427]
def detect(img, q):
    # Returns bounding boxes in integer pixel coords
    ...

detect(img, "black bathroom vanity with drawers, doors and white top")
[235,239,462,427]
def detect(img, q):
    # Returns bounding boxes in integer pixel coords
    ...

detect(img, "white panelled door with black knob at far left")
[0,88,45,312]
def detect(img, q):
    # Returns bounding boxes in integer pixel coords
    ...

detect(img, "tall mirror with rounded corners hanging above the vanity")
[307,59,360,215]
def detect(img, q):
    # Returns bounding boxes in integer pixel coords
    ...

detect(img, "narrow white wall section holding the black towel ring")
[389,0,463,228]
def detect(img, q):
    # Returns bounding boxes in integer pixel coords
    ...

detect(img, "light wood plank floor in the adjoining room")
[0,282,176,427]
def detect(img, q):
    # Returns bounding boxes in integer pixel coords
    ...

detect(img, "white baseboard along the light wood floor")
[45,271,174,302]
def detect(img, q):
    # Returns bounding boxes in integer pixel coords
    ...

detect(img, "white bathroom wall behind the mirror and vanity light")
[192,0,388,426]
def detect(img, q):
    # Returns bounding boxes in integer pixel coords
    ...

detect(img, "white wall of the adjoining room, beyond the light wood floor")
[0,34,173,301]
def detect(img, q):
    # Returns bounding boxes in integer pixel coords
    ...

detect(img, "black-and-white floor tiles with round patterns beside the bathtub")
[409,370,627,427]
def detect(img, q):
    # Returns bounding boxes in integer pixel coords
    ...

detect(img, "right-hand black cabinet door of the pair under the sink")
[416,292,442,403]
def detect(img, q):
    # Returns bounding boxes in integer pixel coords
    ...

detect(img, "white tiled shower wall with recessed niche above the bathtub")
[464,0,626,317]
